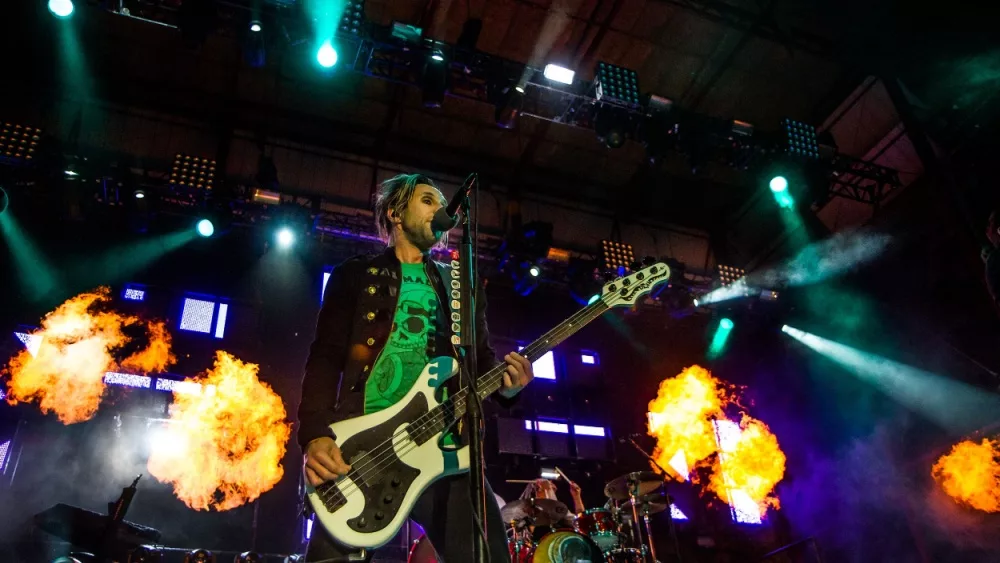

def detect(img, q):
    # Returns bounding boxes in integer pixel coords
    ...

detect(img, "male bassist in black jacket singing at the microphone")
[298,174,534,563]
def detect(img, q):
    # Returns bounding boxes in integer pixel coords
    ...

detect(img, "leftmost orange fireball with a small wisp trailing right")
[3,287,176,424]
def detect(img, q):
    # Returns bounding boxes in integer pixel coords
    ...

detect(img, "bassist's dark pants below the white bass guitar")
[306,473,510,563]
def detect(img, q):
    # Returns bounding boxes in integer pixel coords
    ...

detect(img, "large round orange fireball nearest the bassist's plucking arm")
[147,351,291,511]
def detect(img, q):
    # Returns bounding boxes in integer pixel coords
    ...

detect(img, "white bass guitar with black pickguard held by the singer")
[307,263,670,548]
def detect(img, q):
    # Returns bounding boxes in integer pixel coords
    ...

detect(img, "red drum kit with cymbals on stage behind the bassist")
[500,471,670,563]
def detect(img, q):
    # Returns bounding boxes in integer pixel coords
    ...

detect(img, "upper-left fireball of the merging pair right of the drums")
[646,366,732,480]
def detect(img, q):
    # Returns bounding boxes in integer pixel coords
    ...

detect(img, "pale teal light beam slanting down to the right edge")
[781,325,1000,436]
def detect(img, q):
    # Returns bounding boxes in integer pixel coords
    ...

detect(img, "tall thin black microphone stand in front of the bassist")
[459,183,490,563]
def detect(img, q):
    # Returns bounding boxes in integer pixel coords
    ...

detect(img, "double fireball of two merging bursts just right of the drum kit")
[647,366,785,515]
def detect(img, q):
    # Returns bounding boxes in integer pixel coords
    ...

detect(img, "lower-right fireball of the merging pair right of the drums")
[708,415,785,516]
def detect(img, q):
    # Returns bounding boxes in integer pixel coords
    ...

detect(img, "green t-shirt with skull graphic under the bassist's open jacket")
[365,264,438,414]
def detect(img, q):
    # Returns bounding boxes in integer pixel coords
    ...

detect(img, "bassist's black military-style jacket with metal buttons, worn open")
[298,247,500,449]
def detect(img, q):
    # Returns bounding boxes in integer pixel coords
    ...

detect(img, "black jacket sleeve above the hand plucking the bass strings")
[298,260,360,449]
